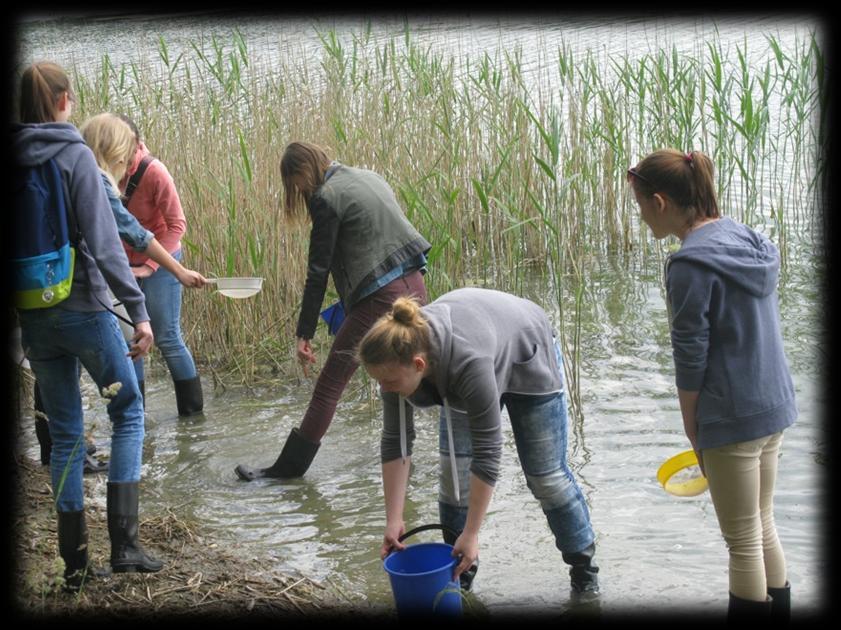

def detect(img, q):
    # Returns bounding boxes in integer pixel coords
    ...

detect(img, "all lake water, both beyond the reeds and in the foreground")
[14,15,829,616]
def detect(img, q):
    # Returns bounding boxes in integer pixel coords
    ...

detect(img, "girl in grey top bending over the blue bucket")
[358,288,599,601]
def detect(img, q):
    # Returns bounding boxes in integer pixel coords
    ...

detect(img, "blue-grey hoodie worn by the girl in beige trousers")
[666,218,797,449]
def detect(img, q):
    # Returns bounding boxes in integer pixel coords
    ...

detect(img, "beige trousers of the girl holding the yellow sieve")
[701,432,786,601]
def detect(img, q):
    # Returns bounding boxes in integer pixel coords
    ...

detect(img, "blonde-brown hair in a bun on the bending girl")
[356,297,429,366]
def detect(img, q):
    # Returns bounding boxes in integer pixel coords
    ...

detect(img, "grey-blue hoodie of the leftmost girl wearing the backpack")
[12,123,149,323]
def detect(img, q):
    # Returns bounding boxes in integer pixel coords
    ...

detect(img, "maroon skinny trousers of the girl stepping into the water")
[300,270,427,443]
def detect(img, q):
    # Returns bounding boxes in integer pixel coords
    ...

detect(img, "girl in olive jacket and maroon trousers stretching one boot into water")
[235,142,431,481]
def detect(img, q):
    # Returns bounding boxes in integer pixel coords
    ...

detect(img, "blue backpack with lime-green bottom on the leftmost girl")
[11,159,76,309]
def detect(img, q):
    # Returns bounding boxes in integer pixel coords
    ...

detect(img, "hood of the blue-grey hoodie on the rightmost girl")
[670,217,780,297]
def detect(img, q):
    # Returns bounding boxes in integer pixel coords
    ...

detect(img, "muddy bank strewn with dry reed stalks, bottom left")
[10,456,364,621]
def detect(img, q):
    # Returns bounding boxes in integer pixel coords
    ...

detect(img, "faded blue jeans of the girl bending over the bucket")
[438,343,595,553]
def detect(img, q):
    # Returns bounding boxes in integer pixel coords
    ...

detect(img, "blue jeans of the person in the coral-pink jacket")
[134,249,196,381]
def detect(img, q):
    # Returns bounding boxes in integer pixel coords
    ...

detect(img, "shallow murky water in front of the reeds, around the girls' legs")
[14,242,827,615]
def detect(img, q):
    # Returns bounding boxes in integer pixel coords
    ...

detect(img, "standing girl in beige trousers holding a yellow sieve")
[628,149,797,621]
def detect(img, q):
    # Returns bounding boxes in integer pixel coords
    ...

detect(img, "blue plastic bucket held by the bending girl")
[383,543,461,617]
